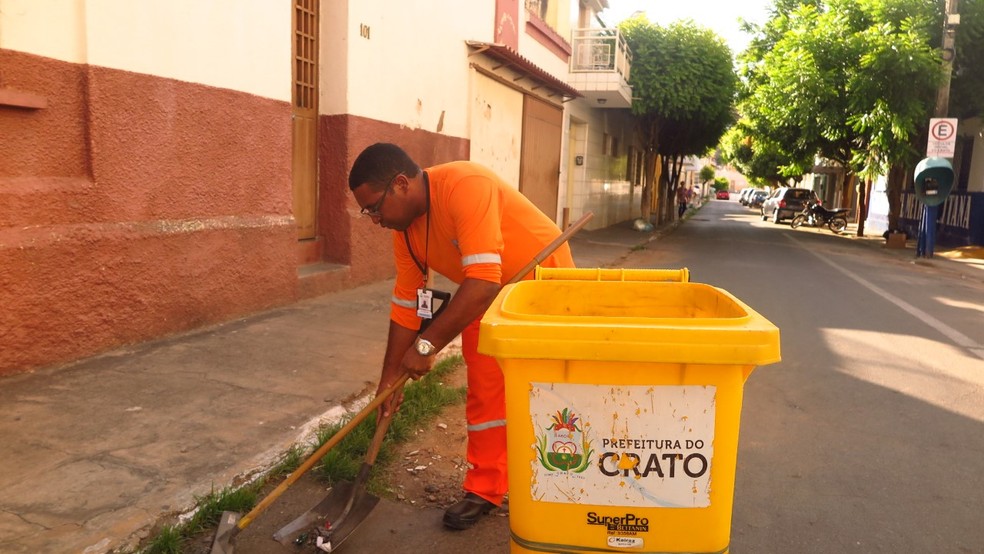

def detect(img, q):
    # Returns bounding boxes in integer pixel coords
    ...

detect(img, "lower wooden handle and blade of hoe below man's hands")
[210,375,409,554]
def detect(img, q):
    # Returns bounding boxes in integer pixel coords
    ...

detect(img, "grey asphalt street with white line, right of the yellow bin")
[625,201,984,554]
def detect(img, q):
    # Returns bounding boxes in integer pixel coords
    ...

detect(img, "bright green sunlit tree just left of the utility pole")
[741,0,940,234]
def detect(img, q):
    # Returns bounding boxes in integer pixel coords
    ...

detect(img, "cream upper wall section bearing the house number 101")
[338,0,495,136]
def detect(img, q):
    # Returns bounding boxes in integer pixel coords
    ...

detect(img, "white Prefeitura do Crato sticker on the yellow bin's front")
[532,382,716,506]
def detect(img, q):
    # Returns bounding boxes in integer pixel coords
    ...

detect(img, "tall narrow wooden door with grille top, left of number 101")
[291,0,319,239]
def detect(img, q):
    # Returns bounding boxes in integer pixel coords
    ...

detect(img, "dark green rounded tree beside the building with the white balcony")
[619,15,737,221]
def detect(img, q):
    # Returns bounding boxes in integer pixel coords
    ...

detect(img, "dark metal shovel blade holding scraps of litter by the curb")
[273,481,379,552]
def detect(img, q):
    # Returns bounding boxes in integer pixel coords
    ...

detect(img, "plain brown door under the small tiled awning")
[519,95,564,221]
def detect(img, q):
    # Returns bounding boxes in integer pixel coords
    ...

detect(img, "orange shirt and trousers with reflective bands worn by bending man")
[390,161,574,505]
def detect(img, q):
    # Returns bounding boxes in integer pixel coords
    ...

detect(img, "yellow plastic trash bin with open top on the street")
[479,274,780,553]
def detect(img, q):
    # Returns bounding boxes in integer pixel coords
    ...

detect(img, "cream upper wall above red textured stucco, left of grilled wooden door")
[0,0,291,102]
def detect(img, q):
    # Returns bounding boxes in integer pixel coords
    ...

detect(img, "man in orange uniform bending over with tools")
[349,143,574,529]
